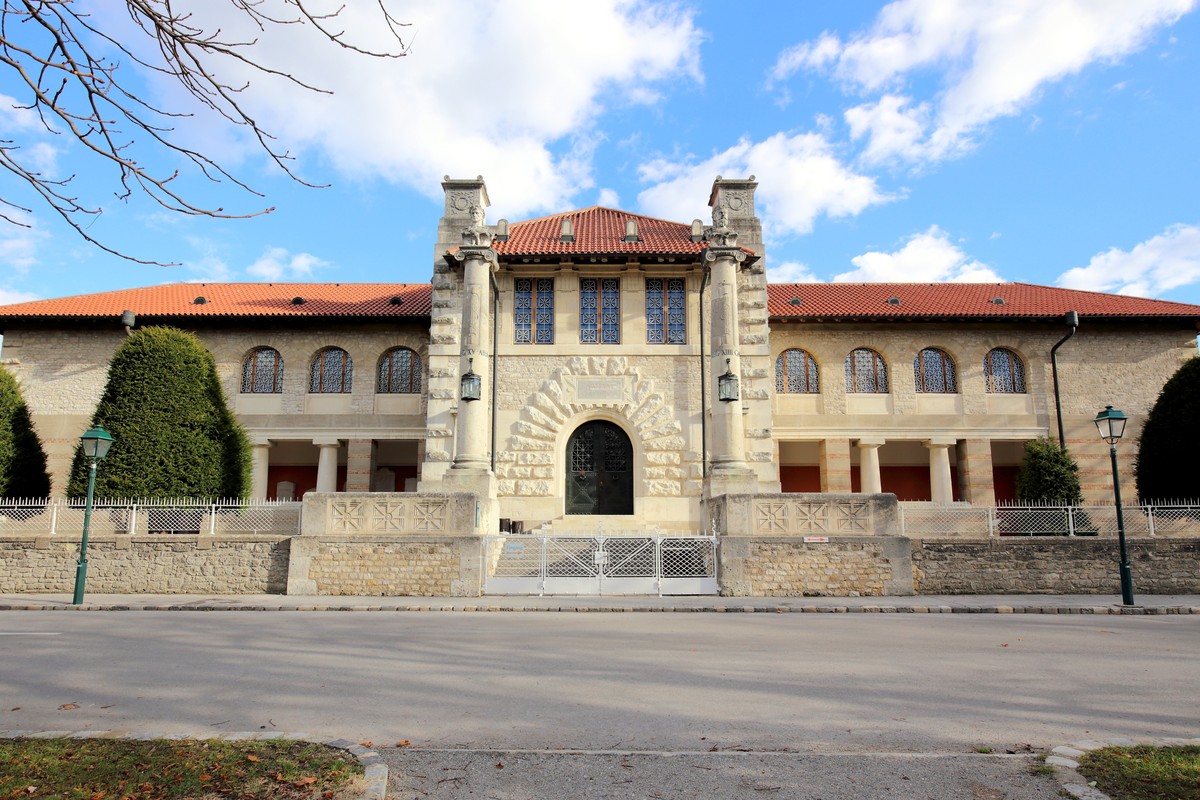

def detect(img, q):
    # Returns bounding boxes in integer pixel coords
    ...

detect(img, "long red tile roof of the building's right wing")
[767,283,1200,321]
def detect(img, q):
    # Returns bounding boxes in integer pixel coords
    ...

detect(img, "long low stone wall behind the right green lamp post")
[912,536,1200,595]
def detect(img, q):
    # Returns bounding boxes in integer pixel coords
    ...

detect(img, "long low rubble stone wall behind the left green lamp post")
[0,535,290,595]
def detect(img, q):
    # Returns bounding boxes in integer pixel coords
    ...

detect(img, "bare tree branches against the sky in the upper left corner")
[0,0,408,264]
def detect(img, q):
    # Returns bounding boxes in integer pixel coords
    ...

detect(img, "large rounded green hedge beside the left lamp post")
[67,327,250,499]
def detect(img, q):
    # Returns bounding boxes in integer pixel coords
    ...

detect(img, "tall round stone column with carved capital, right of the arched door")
[704,206,758,497]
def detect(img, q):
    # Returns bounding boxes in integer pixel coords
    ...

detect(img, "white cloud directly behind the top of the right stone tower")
[638,133,892,239]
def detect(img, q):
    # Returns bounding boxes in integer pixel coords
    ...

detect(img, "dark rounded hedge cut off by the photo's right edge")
[1136,356,1200,503]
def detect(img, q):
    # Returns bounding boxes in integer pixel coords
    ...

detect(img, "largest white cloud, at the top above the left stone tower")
[171,0,702,218]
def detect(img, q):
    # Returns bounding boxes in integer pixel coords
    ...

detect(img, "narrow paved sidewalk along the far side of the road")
[0,593,1200,614]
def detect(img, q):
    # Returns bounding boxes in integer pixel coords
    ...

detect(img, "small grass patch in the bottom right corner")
[1079,745,1200,800]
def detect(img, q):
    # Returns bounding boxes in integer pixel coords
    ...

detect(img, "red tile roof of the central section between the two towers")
[494,205,707,258]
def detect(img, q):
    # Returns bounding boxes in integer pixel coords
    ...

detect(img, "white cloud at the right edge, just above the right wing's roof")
[1057,224,1200,297]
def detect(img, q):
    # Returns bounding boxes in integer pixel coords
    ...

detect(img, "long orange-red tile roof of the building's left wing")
[0,283,430,321]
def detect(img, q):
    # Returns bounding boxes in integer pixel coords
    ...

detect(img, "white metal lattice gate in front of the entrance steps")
[484,535,718,595]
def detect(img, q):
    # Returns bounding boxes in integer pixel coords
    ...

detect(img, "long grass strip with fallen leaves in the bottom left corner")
[0,739,362,800]
